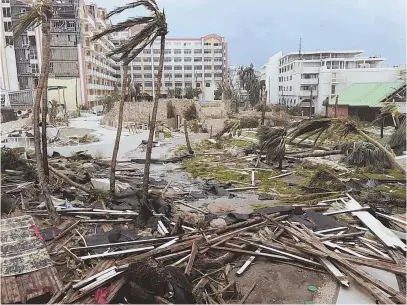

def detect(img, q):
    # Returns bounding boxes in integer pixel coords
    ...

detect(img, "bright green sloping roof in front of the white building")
[338,82,404,107]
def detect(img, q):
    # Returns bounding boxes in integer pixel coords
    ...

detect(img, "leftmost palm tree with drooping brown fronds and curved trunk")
[13,0,59,223]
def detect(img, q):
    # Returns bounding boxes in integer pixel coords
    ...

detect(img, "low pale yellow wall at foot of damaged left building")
[48,78,82,111]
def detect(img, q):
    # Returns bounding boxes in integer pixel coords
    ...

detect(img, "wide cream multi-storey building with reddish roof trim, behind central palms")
[114,28,228,100]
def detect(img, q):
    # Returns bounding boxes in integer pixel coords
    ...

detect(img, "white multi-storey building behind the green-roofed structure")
[261,51,400,114]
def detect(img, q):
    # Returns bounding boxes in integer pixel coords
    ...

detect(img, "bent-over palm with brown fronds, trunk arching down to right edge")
[289,118,406,175]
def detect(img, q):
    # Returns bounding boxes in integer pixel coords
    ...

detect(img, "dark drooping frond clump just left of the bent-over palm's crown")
[257,126,287,162]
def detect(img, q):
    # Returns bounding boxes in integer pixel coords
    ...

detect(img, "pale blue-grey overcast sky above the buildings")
[96,0,406,68]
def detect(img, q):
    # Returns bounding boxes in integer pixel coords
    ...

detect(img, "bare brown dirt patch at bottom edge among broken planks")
[229,258,337,304]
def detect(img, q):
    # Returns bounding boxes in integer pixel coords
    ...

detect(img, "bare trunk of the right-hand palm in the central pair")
[139,34,165,223]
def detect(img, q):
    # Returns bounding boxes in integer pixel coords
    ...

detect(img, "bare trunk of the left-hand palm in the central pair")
[110,61,129,195]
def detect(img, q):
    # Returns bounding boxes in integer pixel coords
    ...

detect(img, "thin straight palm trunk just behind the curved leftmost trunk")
[41,27,51,178]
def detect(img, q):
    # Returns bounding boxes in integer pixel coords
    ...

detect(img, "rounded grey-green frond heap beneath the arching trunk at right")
[340,142,391,168]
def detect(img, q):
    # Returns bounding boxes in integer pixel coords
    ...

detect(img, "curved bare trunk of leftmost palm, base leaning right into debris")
[33,22,59,223]
